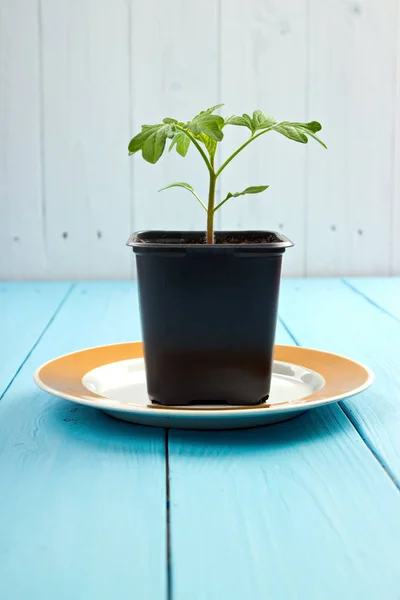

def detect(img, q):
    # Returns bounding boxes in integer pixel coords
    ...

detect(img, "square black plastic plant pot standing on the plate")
[127,231,293,405]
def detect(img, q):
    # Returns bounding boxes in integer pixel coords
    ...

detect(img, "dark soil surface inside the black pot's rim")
[135,231,282,245]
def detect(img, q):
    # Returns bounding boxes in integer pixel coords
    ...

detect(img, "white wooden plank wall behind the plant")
[0,0,400,279]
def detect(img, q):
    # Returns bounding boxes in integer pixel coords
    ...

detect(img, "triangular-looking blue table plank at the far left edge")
[0,282,71,398]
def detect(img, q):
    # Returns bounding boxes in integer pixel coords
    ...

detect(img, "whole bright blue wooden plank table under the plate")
[0,279,400,600]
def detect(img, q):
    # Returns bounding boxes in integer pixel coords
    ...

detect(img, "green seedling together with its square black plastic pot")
[127,104,326,406]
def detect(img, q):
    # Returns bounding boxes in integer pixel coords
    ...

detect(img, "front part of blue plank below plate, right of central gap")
[169,322,400,600]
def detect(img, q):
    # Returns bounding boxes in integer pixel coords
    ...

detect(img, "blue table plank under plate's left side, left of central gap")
[0,283,167,600]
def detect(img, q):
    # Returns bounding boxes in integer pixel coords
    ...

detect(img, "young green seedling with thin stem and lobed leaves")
[128,104,326,244]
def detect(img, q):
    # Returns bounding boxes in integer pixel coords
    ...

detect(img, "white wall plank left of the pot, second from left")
[41,0,131,279]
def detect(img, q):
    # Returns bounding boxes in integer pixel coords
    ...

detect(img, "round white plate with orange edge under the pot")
[34,342,374,429]
